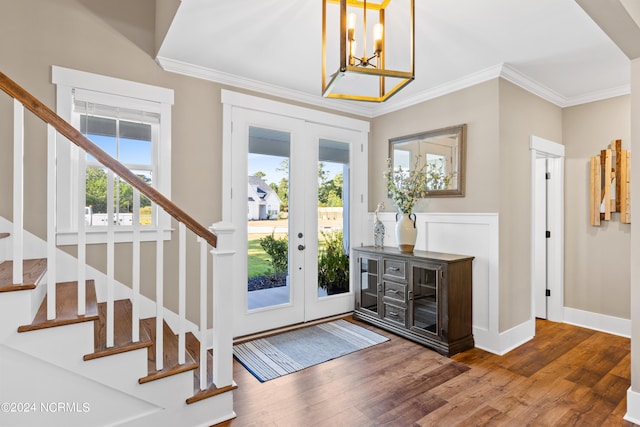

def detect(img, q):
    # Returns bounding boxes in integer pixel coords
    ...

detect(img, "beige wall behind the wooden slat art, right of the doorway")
[563,96,631,319]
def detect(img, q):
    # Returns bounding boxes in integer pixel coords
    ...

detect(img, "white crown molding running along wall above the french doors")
[156,56,373,118]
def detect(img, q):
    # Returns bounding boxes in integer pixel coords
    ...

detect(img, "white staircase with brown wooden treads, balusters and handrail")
[0,73,236,426]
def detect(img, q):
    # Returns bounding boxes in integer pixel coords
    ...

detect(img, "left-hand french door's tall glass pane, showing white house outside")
[247,127,291,310]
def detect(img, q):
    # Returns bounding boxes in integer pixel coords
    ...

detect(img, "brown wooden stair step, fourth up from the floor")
[18,280,98,332]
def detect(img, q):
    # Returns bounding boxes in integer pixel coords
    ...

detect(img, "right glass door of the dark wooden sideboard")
[409,263,440,335]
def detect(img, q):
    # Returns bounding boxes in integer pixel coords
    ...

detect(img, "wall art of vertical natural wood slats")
[589,139,631,226]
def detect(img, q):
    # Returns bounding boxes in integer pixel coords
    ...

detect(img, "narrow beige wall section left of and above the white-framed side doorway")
[498,79,562,332]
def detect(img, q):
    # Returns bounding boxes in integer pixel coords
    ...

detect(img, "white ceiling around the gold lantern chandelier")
[158,0,629,117]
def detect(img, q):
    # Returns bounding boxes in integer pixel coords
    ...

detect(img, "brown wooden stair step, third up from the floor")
[84,299,153,360]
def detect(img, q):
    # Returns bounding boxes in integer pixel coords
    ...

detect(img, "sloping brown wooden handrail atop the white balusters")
[0,72,217,247]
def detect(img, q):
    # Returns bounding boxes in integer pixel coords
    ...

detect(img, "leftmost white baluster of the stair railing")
[11,99,23,294]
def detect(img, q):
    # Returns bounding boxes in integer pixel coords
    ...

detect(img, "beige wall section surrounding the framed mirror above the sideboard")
[369,80,499,216]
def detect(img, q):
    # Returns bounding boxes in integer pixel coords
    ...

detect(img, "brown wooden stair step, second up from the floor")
[138,317,198,384]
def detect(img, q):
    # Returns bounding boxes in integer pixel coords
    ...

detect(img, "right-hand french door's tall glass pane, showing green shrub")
[318,138,349,297]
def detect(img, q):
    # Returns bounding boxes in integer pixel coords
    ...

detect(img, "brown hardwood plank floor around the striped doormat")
[220,318,634,427]
